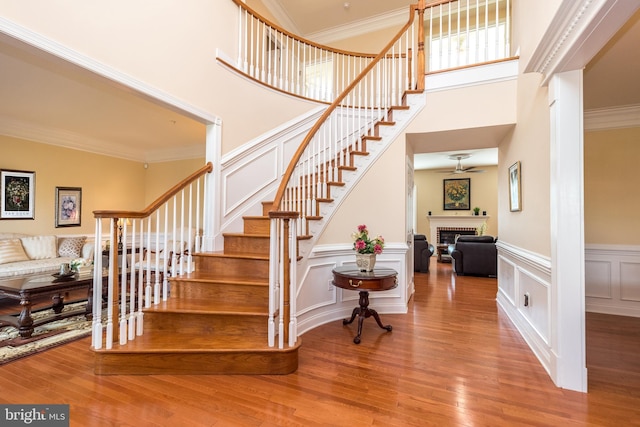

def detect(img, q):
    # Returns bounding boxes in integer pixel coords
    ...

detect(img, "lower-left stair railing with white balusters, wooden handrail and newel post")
[91,162,213,349]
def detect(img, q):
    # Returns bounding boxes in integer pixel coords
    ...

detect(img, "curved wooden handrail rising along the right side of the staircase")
[270,4,418,211]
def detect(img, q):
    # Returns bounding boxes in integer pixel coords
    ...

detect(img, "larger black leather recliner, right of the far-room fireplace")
[449,236,498,277]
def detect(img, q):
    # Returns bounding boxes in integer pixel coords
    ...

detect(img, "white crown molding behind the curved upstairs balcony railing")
[305,7,409,44]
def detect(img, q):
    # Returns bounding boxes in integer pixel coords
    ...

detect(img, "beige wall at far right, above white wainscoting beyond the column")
[584,127,640,245]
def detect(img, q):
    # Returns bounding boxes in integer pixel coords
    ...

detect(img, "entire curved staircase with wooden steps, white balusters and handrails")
[93,5,425,375]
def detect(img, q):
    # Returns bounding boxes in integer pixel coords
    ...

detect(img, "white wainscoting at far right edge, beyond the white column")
[585,245,640,317]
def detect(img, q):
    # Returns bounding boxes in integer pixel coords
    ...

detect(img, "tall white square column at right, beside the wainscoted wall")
[549,70,587,392]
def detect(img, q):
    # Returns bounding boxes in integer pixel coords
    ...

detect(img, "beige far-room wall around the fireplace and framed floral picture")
[415,166,498,243]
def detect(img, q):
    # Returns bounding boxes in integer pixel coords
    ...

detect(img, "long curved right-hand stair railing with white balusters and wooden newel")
[269,5,418,348]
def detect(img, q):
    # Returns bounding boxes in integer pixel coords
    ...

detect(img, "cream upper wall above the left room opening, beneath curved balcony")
[2,0,317,157]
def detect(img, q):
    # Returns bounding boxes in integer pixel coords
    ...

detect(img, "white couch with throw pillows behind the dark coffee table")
[0,233,94,279]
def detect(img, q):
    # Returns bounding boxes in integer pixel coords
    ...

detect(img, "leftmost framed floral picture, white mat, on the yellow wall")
[0,170,36,219]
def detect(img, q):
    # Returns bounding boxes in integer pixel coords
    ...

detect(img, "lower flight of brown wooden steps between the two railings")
[95,203,301,375]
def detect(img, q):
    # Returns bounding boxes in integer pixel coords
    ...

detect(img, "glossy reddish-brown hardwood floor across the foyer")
[0,258,640,427]
